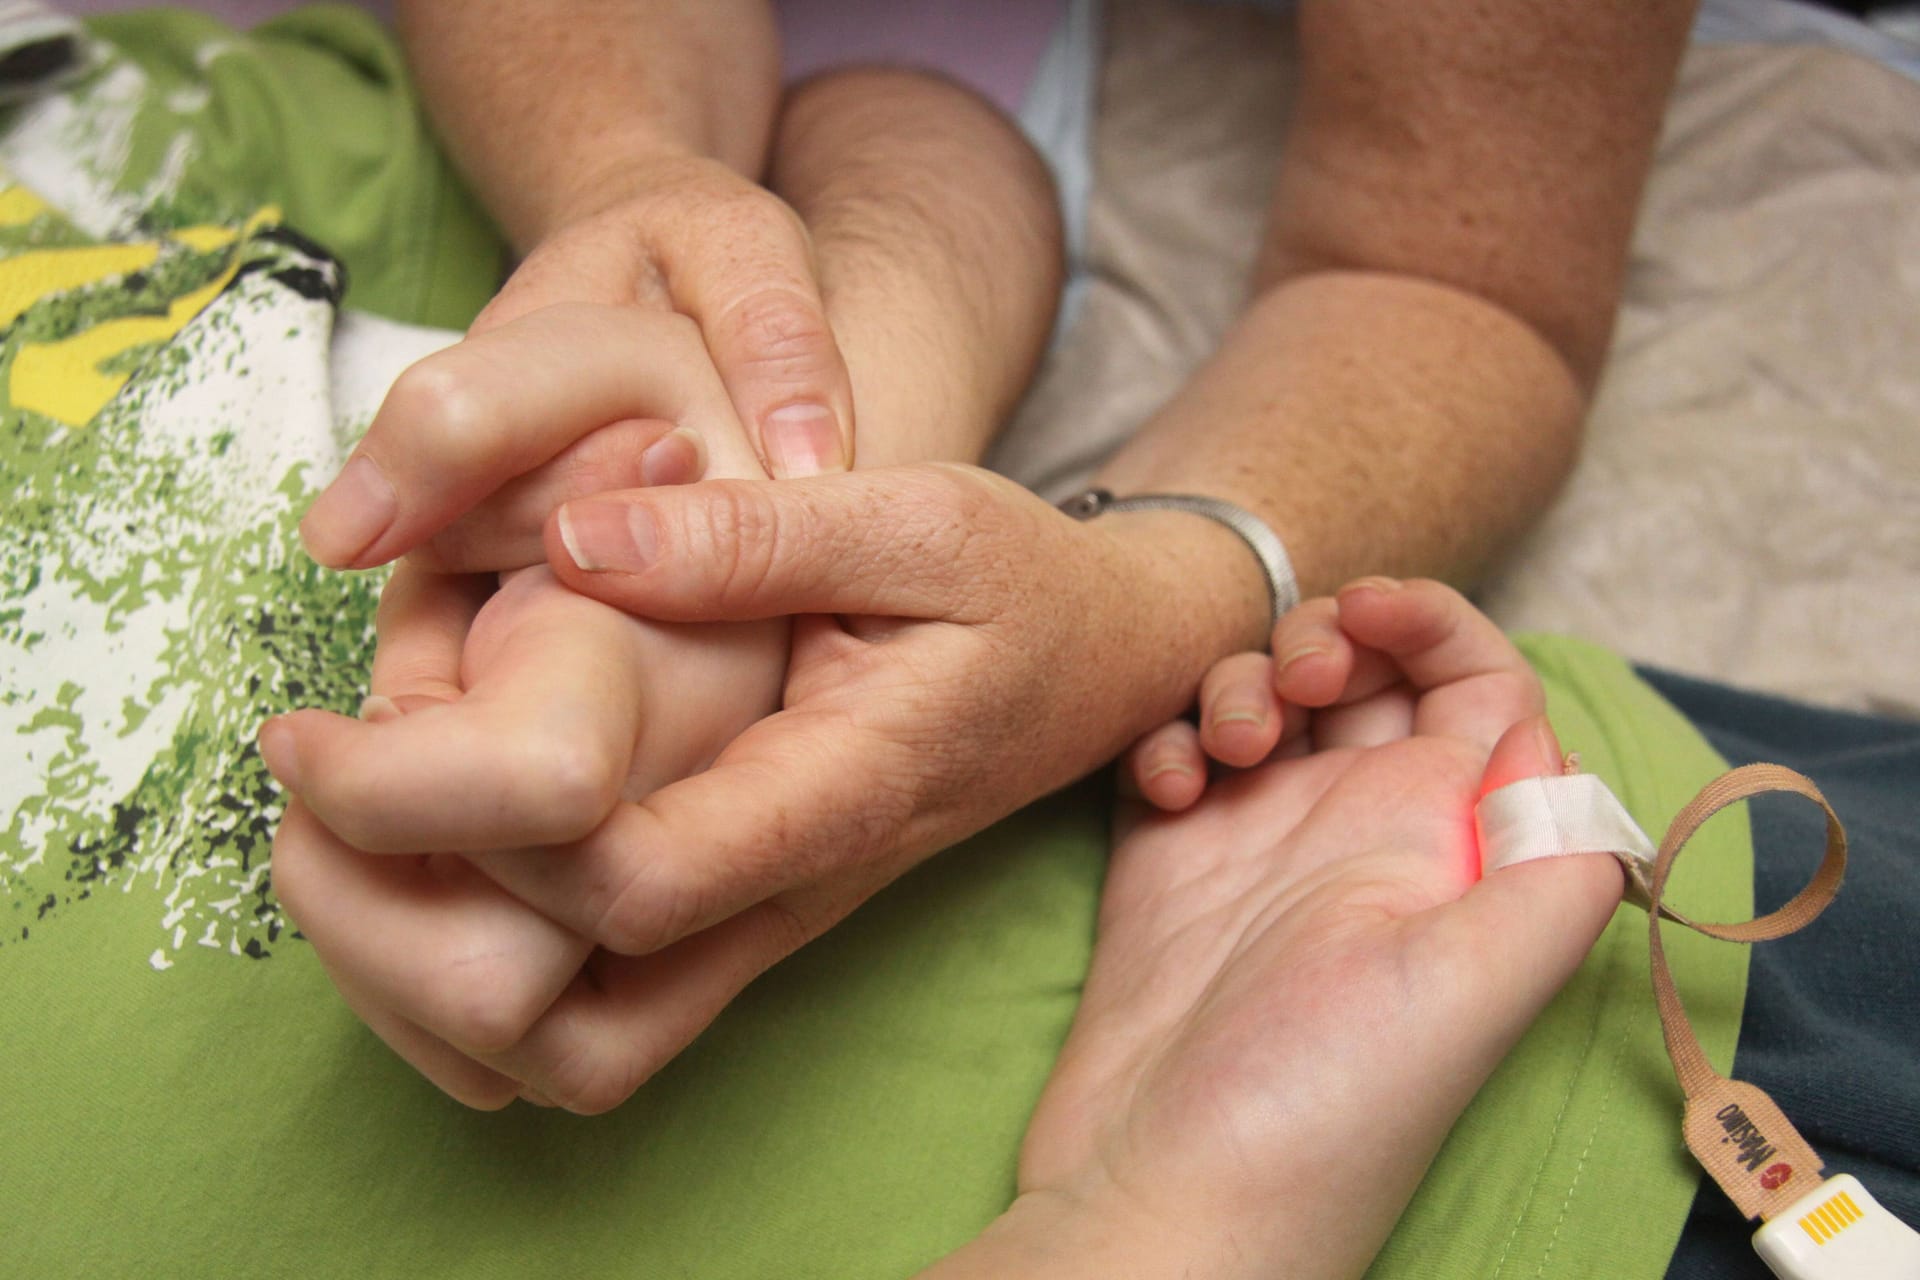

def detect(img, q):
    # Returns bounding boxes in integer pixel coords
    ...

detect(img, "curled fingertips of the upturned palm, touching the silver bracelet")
[1121,578,1532,812]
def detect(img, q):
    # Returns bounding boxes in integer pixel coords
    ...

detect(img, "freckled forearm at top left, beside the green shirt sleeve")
[396,0,780,253]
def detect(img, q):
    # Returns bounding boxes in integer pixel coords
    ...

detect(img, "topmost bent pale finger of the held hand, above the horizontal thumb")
[300,303,766,572]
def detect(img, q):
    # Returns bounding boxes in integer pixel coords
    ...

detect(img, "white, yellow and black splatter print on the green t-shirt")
[0,47,455,969]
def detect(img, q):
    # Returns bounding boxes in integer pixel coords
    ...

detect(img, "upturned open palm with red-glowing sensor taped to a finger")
[931,580,1620,1280]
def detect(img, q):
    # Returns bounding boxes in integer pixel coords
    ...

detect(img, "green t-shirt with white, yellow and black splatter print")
[0,8,1751,1280]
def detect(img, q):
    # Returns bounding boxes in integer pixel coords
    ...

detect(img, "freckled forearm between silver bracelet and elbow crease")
[1100,273,1584,595]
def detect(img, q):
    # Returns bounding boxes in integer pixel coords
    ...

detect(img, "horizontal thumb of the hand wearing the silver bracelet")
[547,464,1021,622]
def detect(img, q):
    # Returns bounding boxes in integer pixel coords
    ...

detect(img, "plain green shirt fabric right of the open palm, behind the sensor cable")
[1367,637,1753,1280]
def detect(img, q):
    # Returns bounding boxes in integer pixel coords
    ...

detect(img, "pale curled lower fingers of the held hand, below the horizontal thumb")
[261,564,787,1105]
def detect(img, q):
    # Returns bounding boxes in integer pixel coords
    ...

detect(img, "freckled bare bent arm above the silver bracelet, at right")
[1102,0,1693,645]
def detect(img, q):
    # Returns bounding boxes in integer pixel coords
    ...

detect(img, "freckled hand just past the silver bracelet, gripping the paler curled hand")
[263,466,1260,1111]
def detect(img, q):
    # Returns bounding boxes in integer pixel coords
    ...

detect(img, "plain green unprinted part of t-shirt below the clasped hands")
[0,793,1104,1280]
